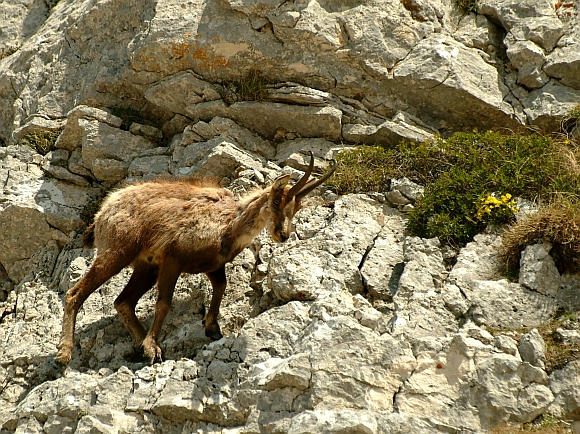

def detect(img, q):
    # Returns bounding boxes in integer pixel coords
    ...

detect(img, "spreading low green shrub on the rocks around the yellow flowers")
[327,131,580,246]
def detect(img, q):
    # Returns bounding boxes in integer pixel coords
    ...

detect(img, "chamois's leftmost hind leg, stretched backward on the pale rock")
[55,250,130,365]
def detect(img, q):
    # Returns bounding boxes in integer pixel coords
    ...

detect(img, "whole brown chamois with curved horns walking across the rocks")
[55,152,336,365]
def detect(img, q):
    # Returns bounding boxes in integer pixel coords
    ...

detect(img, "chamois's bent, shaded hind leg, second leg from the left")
[115,262,158,346]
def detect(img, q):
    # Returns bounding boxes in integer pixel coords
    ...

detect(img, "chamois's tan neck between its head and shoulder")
[232,188,270,251]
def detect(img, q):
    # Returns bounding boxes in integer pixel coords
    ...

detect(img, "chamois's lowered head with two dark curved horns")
[268,152,336,243]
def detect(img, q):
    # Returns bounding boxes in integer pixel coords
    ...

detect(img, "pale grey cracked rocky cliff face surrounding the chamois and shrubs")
[0,0,580,434]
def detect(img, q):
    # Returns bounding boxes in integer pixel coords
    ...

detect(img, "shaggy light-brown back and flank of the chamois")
[95,179,236,254]
